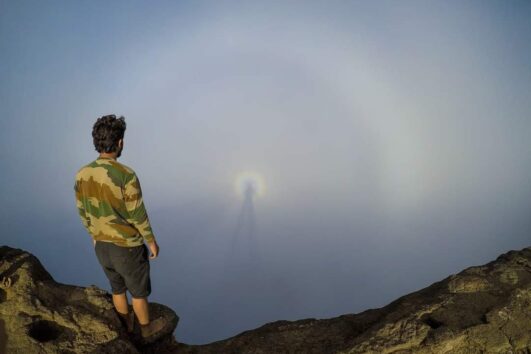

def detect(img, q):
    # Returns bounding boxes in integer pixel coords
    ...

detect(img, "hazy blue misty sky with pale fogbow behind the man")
[0,1,531,343]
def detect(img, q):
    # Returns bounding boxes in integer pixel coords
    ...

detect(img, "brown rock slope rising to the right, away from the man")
[171,247,531,354]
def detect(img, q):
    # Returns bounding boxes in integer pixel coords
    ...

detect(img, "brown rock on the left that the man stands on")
[0,246,178,354]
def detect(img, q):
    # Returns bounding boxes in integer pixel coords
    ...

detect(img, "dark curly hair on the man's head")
[92,114,125,153]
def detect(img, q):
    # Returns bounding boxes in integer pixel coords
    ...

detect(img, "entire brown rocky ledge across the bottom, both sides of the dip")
[0,247,531,354]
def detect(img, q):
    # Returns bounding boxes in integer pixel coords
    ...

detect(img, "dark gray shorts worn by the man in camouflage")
[95,241,151,298]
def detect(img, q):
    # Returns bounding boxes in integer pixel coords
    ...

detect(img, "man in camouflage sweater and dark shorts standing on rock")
[74,115,165,340]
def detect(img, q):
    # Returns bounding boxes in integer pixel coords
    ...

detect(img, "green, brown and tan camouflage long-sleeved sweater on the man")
[74,157,154,247]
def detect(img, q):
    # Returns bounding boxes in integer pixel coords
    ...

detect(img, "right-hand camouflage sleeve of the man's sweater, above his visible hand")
[123,173,155,242]
